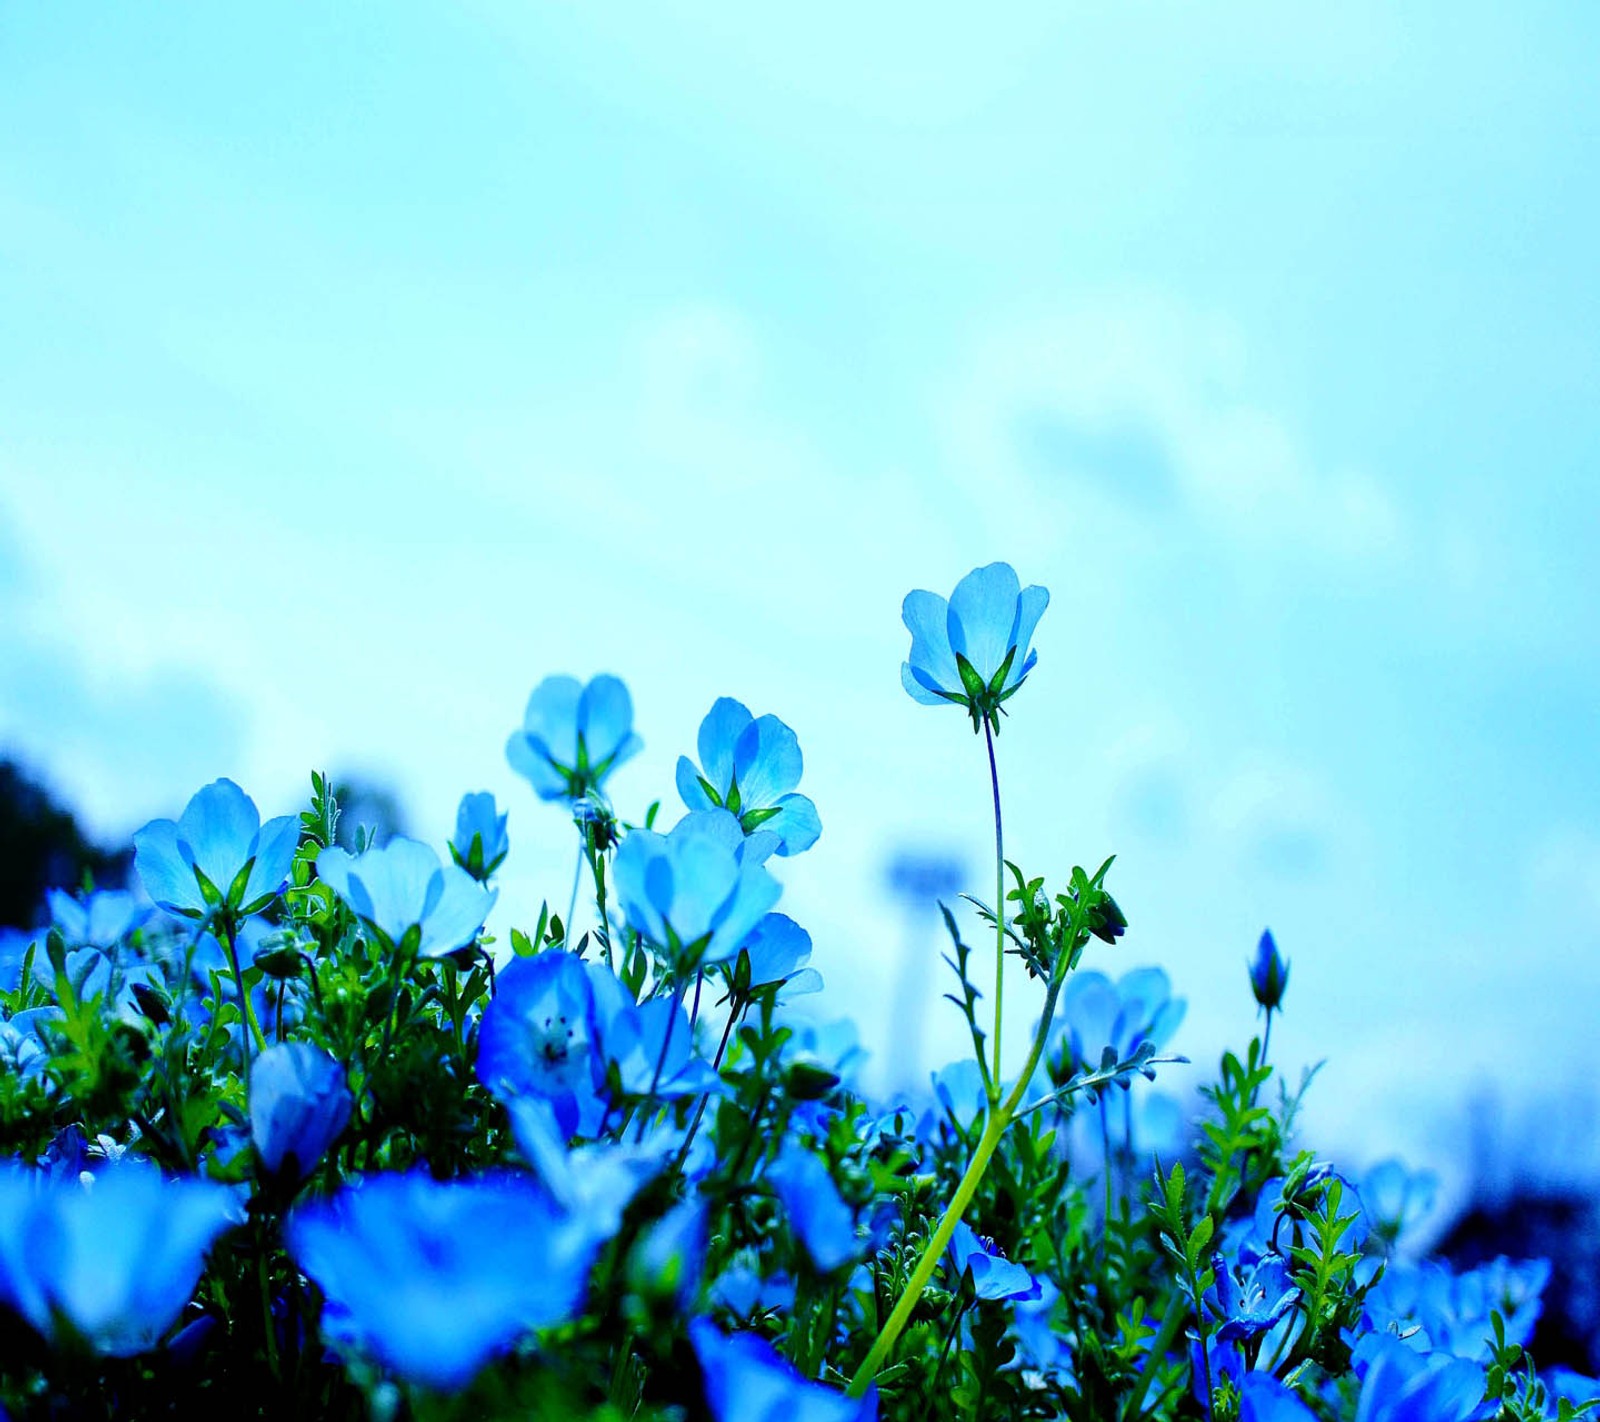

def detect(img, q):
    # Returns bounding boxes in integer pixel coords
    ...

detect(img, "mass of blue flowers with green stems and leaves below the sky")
[0,563,1597,1422]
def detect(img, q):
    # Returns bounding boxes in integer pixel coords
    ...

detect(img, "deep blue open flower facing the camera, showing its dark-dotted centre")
[478,949,608,1137]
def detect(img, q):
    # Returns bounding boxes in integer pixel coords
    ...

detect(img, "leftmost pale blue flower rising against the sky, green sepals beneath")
[133,781,299,918]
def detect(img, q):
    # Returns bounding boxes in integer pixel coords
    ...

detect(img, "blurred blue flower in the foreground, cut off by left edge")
[0,1160,240,1358]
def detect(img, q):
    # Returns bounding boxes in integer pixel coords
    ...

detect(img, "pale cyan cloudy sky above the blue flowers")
[0,0,1600,1196]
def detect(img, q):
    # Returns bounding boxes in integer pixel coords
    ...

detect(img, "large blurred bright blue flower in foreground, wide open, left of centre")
[285,1171,602,1392]
